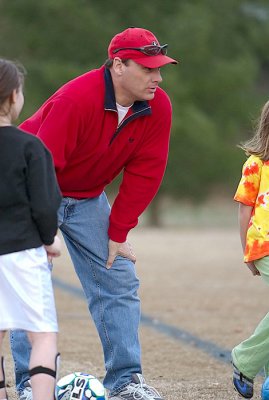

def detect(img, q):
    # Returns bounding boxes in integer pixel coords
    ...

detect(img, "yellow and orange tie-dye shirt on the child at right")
[234,155,269,262]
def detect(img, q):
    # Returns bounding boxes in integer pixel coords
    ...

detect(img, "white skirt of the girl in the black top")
[0,246,58,332]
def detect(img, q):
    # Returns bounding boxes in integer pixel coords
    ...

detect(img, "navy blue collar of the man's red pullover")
[104,68,151,115]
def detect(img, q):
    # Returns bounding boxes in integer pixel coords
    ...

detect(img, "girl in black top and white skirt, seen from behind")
[0,59,61,400]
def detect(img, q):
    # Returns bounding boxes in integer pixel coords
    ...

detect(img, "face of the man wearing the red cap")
[115,60,162,105]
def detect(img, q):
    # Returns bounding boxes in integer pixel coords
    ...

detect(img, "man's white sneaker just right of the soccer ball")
[108,374,164,400]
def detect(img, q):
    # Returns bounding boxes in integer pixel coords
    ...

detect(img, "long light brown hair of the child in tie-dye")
[239,101,269,161]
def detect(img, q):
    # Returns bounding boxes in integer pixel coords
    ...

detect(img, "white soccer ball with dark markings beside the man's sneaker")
[55,372,106,400]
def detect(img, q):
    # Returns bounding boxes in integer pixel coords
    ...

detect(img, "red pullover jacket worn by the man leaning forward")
[20,66,172,242]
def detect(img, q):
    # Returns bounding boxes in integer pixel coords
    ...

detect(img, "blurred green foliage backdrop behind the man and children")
[0,0,269,224]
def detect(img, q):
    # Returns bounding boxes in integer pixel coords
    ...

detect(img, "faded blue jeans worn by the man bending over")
[11,193,141,394]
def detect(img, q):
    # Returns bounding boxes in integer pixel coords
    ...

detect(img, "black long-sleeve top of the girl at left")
[0,126,61,255]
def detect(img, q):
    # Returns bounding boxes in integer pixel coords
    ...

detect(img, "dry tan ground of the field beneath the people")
[2,227,268,400]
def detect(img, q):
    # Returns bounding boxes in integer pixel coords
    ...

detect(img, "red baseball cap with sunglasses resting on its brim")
[108,28,178,68]
